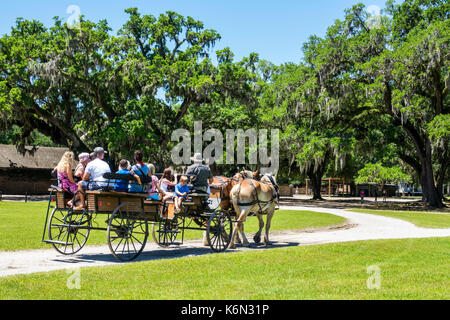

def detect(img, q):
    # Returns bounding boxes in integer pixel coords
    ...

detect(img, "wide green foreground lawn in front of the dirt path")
[0,238,450,299]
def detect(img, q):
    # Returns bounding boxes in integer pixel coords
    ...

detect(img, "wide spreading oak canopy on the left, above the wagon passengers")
[0,8,253,165]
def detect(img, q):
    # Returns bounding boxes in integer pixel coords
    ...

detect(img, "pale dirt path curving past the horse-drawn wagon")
[0,206,450,277]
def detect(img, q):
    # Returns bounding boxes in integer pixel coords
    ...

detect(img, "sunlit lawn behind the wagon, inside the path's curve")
[0,201,345,251]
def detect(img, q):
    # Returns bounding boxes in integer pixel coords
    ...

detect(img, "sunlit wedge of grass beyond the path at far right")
[348,209,450,229]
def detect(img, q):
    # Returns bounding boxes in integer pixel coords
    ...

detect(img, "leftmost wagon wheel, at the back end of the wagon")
[48,208,91,255]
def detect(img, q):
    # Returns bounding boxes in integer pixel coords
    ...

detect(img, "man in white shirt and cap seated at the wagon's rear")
[74,147,111,210]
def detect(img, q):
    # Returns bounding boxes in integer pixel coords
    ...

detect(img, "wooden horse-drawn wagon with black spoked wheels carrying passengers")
[42,174,233,261]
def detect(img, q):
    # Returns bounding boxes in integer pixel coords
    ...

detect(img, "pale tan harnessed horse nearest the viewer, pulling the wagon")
[229,174,279,249]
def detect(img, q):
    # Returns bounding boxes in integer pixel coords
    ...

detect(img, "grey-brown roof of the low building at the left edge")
[0,144,69,169]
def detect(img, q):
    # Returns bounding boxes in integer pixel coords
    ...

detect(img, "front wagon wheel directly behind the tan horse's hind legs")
[206,210,233,252]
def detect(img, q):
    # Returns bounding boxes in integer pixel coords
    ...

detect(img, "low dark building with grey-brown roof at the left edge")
[0,144,68,195]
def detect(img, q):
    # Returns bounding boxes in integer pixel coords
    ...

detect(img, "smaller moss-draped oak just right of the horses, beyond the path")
[262,63,354,200]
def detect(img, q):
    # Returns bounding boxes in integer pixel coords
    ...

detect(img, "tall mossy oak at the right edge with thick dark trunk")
[300,0,450,207]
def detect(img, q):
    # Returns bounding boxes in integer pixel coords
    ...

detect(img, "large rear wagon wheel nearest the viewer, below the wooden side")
[107,202,148,261]
